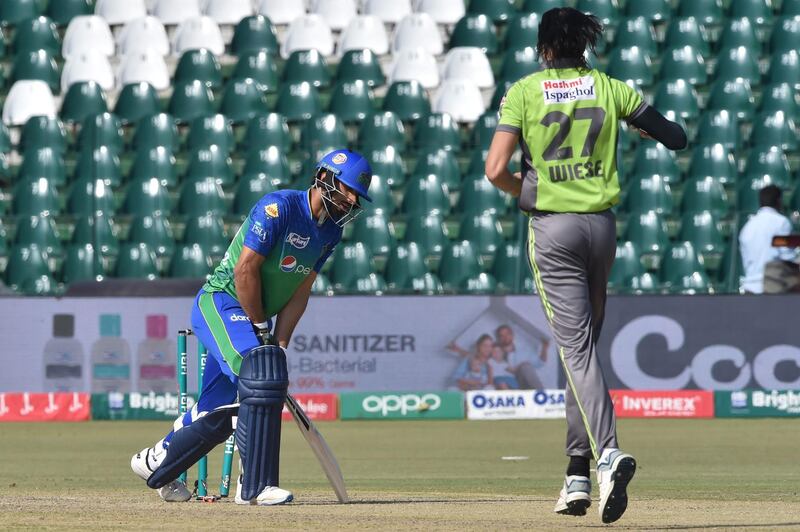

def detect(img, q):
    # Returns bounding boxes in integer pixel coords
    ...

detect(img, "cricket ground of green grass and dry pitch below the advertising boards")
[0,419,800,531]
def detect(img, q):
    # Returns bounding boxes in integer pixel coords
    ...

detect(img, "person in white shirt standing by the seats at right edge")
[739,185,797,294]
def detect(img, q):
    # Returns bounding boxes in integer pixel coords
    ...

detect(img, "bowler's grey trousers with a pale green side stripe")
[528,211,617,460]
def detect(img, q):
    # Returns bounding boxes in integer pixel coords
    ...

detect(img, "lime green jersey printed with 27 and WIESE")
[497,67,646,212]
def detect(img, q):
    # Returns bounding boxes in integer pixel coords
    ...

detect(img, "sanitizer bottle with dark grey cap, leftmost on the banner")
[44,314,85,392]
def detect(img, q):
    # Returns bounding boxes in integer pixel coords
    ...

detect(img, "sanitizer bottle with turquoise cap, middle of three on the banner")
[92,314,131,393]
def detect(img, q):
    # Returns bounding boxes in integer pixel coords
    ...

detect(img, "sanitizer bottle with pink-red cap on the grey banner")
[137,314,177,393]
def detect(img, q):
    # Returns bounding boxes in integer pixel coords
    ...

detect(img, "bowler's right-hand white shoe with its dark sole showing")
[597,449,636,523]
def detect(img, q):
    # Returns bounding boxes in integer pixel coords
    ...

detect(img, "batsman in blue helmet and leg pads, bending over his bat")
[131,150,372,506]
